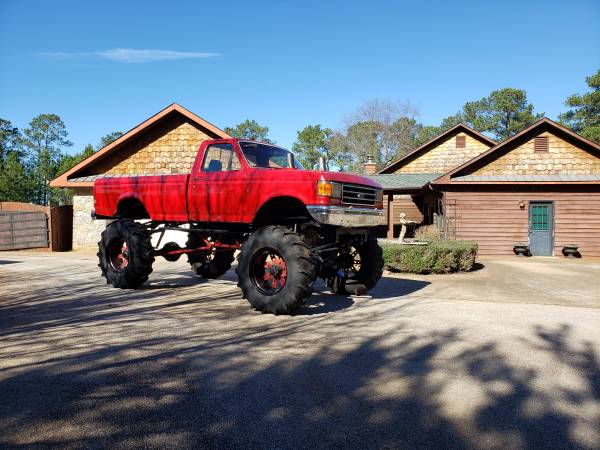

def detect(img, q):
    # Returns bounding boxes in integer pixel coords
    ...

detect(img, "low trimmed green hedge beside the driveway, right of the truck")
[380,241,477,273]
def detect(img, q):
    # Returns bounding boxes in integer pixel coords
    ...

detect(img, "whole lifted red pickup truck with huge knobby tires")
[94,139,383,314]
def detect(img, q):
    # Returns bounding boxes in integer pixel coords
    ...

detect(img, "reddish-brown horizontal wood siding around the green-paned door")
[444,191,600,258]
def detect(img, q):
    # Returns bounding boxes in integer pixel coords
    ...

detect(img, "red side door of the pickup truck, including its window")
[188,143,245,222]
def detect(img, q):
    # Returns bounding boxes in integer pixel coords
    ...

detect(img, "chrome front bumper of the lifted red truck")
[306,205,385,228]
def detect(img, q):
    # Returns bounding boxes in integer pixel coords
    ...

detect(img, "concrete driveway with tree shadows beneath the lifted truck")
[0,252,600,449]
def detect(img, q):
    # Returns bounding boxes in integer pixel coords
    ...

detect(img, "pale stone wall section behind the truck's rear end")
[73,188,110,250]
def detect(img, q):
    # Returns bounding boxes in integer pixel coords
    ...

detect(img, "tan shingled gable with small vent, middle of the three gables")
[395,133,490,173]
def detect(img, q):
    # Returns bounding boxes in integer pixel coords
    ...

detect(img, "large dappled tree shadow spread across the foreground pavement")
[0,310,600,449]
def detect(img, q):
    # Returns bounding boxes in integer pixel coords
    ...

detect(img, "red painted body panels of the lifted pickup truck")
[94,139,383,223]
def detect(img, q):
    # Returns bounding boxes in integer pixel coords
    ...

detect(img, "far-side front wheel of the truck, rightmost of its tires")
[327,237,384,295]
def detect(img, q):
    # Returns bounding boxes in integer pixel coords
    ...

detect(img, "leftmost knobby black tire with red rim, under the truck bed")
[98,219,154,289]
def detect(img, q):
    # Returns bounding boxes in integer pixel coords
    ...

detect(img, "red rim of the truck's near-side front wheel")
[250,248,287,295]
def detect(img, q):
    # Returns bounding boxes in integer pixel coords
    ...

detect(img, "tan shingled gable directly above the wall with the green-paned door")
[473,132,600,175]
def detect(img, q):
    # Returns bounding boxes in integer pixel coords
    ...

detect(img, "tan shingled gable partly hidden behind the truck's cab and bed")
[82,116,211,175]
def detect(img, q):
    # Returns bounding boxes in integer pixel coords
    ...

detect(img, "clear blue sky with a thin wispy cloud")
[0,0,600,155]
